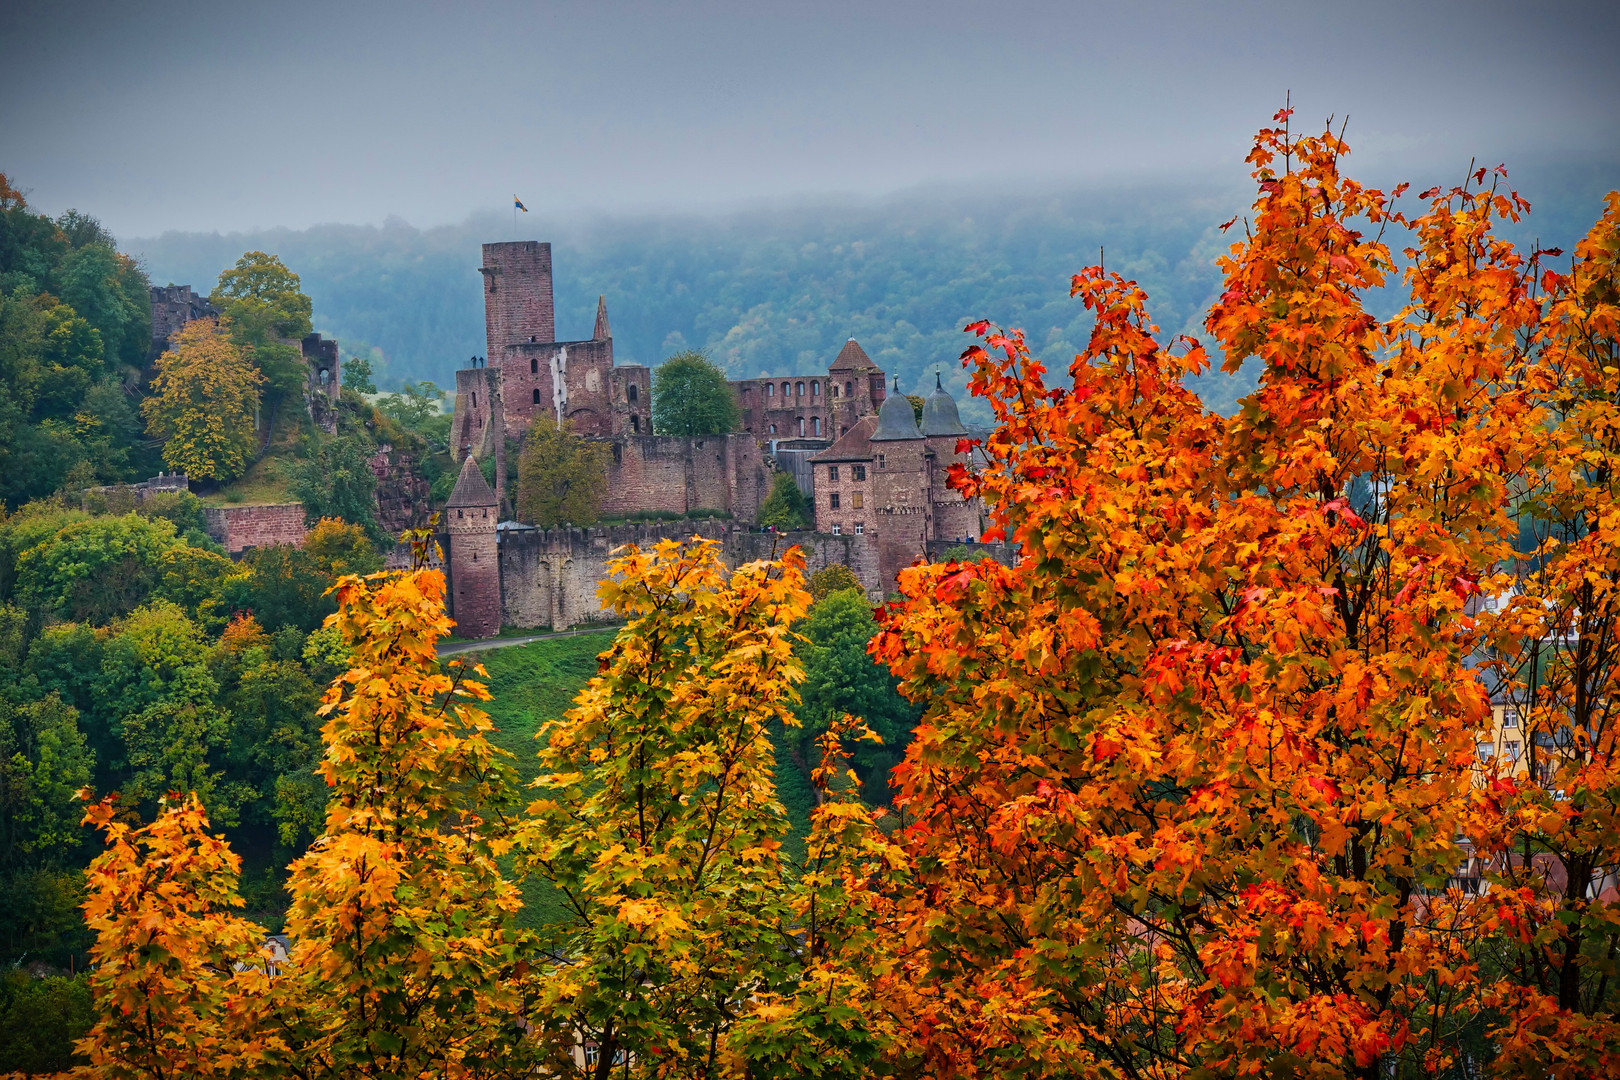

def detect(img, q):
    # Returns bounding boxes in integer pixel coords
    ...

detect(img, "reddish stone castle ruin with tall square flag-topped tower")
[441,241,982,638]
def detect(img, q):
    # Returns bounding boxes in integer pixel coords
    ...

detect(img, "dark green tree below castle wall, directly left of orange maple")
[795,592,920,801]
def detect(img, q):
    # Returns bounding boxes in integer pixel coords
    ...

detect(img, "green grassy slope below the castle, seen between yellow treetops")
[476,633,812,926]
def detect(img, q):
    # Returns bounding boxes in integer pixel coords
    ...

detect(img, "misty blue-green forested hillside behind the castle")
[126,160,1620,419]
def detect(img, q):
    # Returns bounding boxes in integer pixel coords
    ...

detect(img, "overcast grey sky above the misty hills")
[0,0,1620,236]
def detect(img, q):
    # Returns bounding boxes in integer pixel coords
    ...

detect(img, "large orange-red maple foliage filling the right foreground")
[875,112,1620,1077]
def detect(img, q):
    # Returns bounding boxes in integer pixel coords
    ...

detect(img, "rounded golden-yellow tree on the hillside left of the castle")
[141,319,264,481]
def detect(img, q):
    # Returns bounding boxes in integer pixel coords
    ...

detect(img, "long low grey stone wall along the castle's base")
[492,520,893,630]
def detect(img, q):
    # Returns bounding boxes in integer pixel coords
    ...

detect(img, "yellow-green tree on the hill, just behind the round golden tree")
[209,251,314,392]
